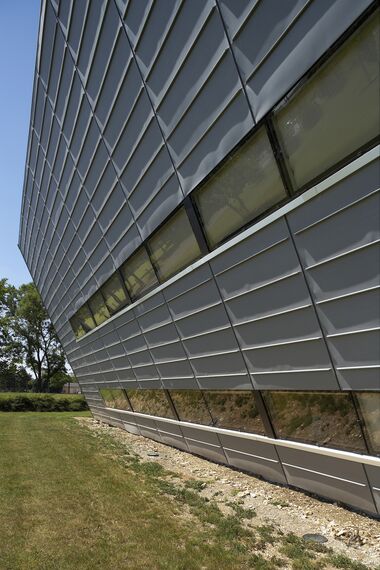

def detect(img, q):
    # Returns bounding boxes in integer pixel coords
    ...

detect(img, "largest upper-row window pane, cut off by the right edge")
[275,12,380,188]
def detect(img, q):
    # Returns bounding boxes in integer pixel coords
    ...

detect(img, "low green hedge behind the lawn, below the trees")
[0,392,88,412]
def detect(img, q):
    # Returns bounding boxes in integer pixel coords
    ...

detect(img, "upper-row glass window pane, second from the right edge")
[196,128,286,247]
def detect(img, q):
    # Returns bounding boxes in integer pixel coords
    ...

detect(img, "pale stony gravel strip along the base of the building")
[77,418,380,568]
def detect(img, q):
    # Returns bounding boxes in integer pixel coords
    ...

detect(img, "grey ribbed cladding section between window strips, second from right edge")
[211,218,337,389]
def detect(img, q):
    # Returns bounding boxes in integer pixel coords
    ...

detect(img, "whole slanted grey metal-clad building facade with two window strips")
[19,0,380,515]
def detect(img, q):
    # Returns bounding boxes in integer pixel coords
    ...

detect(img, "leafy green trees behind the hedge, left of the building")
[0,279,66,392]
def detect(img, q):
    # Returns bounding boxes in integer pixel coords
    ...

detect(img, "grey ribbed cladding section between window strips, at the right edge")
[287,160,380,390]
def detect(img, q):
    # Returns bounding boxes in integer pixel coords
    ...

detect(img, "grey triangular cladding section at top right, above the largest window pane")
[216,0,371,121]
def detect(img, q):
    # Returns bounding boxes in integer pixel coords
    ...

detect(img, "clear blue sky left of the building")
[0,0,40,285]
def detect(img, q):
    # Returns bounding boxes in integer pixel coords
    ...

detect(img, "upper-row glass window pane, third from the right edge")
[148,208,201,282]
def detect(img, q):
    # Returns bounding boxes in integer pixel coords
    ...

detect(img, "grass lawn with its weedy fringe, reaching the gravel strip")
[0,412,372,570]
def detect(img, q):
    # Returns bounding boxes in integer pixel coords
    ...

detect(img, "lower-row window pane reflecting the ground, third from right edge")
[203,390,265,435]
